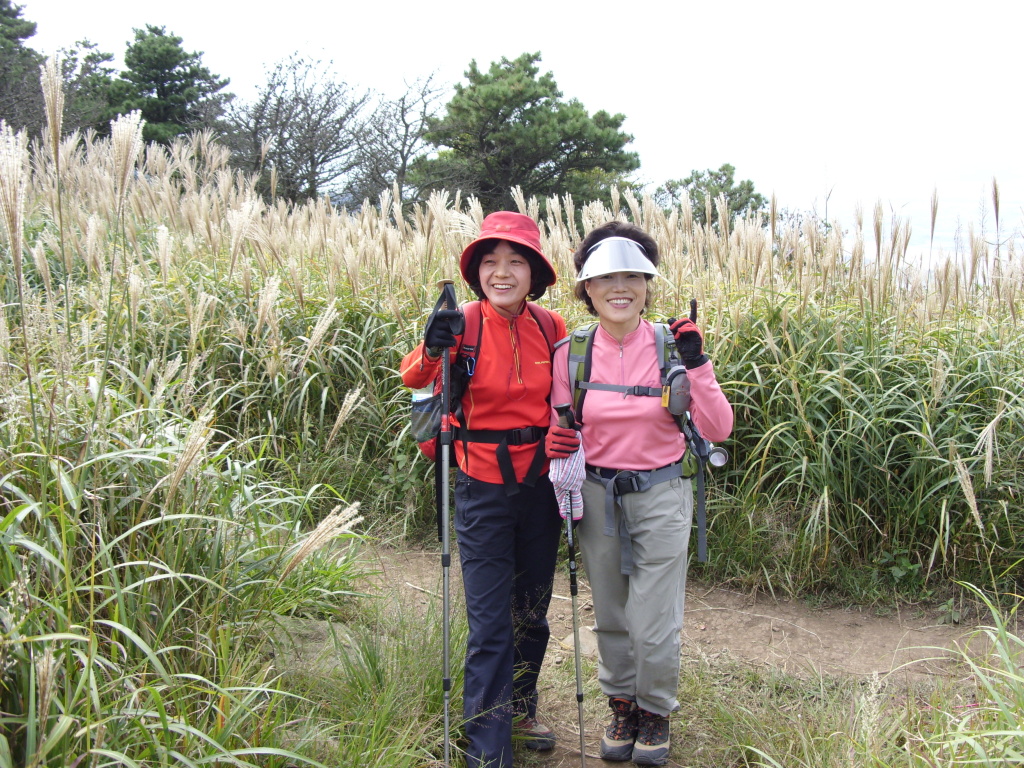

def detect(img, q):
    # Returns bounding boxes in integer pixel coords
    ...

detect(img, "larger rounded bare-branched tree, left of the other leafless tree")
[228,53,370,201]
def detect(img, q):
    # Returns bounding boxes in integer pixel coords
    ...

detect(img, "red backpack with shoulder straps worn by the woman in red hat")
[413,301,556,459]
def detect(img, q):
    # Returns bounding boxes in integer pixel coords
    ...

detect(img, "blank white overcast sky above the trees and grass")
[14,0,1024,259]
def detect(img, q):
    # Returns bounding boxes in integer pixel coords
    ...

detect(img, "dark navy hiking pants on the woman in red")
[455,470,562,768]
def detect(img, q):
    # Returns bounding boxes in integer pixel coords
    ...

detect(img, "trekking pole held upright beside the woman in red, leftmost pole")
[434,280,458,768]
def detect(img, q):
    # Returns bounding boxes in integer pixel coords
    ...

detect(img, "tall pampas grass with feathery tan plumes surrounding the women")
[0,69,1024,768]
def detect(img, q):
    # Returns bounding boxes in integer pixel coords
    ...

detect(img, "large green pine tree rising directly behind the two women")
[414,53,640,209]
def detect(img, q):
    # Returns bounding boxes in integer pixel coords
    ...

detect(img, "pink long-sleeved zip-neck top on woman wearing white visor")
[551,319,732,469]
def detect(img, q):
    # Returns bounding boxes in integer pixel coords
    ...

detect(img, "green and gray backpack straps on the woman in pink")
[556,321,696,476]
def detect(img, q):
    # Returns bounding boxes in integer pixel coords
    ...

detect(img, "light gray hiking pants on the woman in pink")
[578,477,693,716]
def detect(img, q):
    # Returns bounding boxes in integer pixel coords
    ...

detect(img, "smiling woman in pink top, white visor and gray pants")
[548,221,732,765]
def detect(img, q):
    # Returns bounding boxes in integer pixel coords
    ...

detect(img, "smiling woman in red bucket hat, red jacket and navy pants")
[401,211,565,768]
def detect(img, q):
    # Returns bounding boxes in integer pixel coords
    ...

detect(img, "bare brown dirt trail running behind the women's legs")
[358,550,974,768]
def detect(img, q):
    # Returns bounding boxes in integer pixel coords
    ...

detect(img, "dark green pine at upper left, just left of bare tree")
[111,25,231,143]
